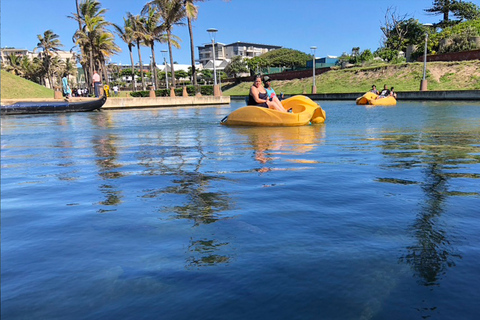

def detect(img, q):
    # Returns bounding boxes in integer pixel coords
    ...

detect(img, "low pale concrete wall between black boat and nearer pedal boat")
[102,96,230,109]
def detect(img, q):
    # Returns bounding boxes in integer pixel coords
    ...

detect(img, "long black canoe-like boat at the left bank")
[0,96,107,115]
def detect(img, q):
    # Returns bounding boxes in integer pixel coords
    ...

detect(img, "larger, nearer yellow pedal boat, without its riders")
[221,95,326,127]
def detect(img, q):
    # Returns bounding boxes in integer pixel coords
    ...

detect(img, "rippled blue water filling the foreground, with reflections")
[1,101,480,320]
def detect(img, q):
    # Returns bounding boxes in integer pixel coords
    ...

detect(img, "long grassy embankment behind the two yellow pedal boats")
[223,60,480,95]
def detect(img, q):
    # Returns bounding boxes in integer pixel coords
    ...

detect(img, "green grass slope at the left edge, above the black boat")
[1,70,54,99]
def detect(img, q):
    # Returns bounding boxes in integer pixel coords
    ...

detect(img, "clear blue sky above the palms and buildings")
[1,0,446,64]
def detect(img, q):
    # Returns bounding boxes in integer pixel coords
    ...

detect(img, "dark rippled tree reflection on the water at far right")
[378,134,472,285]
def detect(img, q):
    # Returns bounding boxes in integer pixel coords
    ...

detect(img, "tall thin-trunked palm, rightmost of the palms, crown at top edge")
[147,0,185,88]
